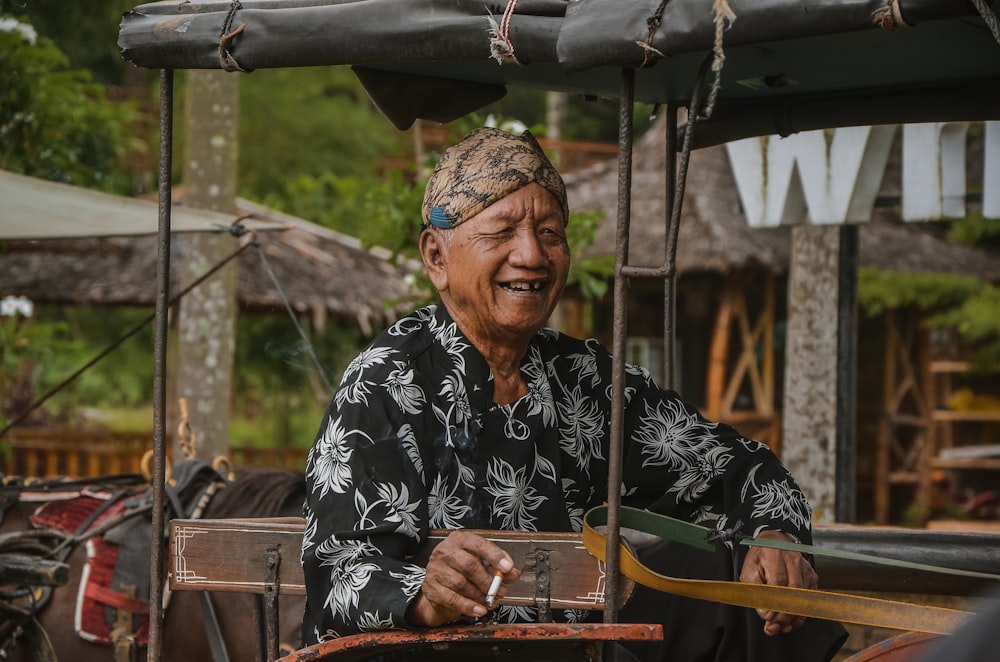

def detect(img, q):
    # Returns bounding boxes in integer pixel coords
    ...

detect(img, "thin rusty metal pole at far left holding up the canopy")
[146,69,174,662]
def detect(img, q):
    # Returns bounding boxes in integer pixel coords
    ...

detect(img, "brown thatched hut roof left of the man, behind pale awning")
[0,199,412,335]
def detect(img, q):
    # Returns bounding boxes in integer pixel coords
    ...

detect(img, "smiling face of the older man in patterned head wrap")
[421,184,570,350]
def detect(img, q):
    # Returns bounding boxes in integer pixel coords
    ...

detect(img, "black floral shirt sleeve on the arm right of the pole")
[623,360,812,542]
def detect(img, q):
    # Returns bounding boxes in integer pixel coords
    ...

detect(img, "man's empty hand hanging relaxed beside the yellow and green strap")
[740,531,819,636]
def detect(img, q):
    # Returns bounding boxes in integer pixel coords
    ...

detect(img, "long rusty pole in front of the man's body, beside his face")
[604,69,635,623]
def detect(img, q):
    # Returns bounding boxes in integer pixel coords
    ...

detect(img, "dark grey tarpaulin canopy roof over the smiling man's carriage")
[118,0,1000,144]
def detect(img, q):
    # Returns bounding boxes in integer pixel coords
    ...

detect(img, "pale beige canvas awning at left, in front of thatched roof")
[0,170,285,239]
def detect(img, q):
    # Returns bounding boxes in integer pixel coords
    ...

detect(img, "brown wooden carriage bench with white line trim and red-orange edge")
[168,518,663,662]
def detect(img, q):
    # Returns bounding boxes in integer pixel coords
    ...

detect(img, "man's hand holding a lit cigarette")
[406,531,521,626]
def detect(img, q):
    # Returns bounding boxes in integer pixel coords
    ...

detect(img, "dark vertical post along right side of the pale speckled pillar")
[834,225,858,523]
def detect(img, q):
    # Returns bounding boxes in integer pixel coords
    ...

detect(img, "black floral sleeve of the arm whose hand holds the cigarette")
[302,366,428,641]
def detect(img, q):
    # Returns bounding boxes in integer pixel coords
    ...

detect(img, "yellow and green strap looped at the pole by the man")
[583,506,980,634]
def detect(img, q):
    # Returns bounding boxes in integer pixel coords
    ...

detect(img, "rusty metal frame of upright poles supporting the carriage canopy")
[147,49,740,662]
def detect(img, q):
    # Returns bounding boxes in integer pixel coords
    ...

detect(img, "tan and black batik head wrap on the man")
[422,127,569,228]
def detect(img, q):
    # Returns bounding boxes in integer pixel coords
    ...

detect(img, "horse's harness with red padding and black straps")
[0,460,226,662]
